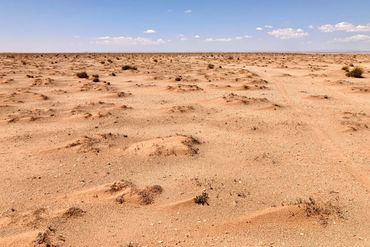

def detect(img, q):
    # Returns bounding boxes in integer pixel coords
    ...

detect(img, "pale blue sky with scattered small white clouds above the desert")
[0,0,370,52]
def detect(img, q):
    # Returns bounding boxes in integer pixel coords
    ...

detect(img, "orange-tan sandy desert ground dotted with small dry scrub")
[0,54,370,247]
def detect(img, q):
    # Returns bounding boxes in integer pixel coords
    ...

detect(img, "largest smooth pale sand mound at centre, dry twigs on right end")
[126,135,199,157]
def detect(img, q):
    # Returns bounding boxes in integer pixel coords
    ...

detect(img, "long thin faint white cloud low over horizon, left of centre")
[96,36,166,46]
